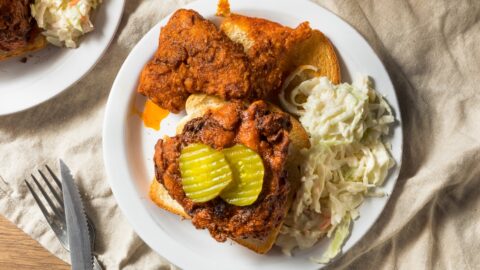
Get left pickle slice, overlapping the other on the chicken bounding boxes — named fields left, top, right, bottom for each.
left=180, top=143, right=233, bottom=202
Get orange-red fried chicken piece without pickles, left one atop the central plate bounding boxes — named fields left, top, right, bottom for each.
left=138, top=9, right=250, bottom=113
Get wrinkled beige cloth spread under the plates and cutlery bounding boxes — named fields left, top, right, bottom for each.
left=0, top=0, right=480, bottom=269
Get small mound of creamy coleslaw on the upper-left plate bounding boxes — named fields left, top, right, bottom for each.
left=31, top=0, right=102, bottom=48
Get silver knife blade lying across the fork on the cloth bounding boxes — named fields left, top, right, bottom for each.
left=60, top=160, right=93, bottom=270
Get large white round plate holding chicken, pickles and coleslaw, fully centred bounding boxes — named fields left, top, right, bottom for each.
left=103, top=0, right=402, bottom=270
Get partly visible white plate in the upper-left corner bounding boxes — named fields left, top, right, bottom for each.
left=0, top=0, right=125, bottom=115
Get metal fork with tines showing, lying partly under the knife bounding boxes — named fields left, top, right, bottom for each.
left=25, top=165, right=103, bottom=270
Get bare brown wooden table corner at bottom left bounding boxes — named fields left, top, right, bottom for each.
left=0, top=216, right=70, bottom=270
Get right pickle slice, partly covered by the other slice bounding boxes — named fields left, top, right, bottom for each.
left=220, top=144, right=265, bottom=206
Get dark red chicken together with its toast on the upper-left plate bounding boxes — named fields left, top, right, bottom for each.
left=0, top=0, right=47, bottom=61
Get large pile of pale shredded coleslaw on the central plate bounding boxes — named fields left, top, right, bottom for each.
left=277, top=76, right=394, bottom=263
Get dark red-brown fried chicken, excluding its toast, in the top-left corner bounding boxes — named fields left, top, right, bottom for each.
left=0, top=0, right=34, bottom=51
